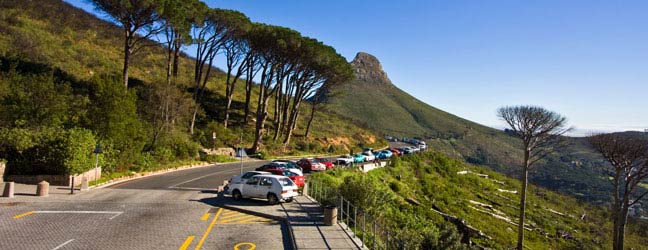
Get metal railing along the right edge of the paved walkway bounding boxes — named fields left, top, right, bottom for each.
left=309, top=182, right=407, bottom=250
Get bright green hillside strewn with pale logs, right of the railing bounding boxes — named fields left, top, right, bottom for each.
left=309, top=152, right=648, bottom=249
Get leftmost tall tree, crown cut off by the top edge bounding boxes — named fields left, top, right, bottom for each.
left=90, top=0, right=163, bottom=87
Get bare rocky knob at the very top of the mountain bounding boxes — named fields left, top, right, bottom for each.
left=351, top=52, right=391, bottom=84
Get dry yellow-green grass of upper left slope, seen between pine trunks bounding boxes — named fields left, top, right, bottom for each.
left=0, top=0, right=385, bottom=154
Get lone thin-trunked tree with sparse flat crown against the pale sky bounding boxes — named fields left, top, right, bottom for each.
left=497, top=106, right=569, bottom=250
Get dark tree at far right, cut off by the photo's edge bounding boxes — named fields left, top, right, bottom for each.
left=588, top=134, right=648, bottom=250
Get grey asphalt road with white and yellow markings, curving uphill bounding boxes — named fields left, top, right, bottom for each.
left=0, top=161, right=289, bottom=250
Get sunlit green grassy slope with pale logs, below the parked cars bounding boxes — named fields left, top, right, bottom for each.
left=311, top=152, right=648, bottom=249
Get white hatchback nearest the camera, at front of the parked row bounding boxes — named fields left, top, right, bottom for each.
left=230, top=174, right=298, bottom=205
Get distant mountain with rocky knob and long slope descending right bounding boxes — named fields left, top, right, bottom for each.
left=326, top=52, right=624, bottom=206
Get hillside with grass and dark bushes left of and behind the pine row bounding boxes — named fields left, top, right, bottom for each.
left=0, top=0, right=386, bottom=176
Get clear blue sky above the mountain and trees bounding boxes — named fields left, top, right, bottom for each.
left=68, top=0, right=648, bottom=133
